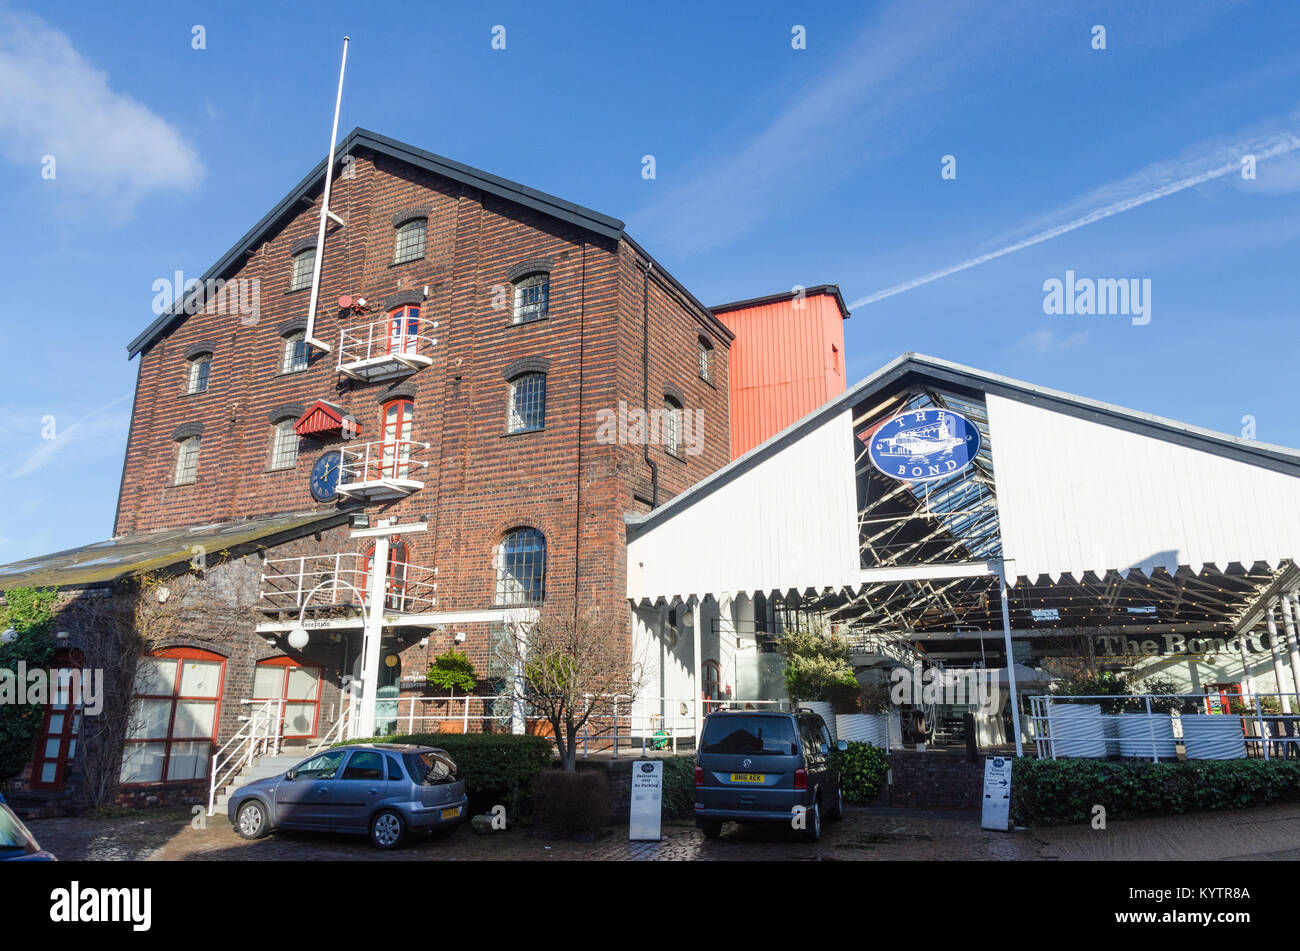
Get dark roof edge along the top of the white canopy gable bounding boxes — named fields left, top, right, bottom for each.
left=624, top=353, right=1300, bottom=542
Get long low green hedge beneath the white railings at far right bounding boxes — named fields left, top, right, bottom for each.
left=1011, top=759, right=1300, bottom=825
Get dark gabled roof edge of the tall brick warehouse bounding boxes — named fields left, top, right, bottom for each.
left=126, top=127, right=731, bottom=359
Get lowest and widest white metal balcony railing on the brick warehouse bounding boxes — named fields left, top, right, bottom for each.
left=257, top=552, right=438, bottom=615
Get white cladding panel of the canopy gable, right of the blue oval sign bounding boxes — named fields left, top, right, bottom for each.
left=988, top=394, right=1300, bottom=579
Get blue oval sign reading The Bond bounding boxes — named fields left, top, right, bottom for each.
left=867, top=407, right=980, bottom=482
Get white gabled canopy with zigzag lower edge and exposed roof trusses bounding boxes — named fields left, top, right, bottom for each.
left=628, top=355, right=1300, bottom=635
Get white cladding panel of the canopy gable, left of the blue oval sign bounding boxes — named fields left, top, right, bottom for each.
left=628, top=409, right=859, bottom=600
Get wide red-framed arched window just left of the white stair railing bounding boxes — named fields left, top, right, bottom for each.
left=121, top=647, right=226, bottom=783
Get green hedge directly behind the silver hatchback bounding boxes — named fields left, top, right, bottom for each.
left=334, top=733, right=555, bottom=813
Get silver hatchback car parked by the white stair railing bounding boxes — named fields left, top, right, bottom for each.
left=229, top=743, right=468, bottom=848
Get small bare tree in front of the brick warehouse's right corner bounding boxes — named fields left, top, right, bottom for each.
left=498, top=611, right=641, bottom=770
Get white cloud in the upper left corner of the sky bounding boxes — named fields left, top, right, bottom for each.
left=0, top=8, right=204, bottom=216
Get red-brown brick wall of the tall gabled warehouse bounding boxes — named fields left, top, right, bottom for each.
left=117, top=140, right=729, bottom=669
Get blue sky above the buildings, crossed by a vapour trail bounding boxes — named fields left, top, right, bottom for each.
left=0, top=0, right=1300, bottom=563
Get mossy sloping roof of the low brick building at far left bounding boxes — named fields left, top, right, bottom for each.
left=0, top=512, right=348, bottom=591
